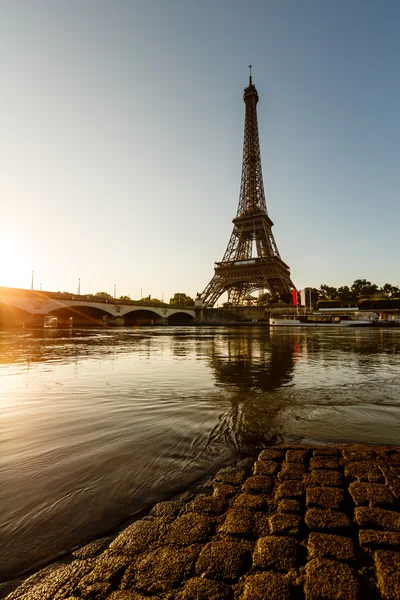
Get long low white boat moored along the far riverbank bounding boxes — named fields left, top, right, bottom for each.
left=269, top=313, right=374, bottom=327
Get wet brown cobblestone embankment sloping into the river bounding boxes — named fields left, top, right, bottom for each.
left=3, top=445, right=400, bottom=600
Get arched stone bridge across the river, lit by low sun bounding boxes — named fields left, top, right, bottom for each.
left=0, top=287, right=196, bottom=327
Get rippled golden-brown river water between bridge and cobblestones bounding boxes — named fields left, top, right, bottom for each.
left=0, top=326, right=400, bottom=581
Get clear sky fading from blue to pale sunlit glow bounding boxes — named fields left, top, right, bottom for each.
left=0, top=0, right=400, bottom=299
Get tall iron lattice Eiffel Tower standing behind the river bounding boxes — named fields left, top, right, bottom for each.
left=196, top=66, right=296, bottom=307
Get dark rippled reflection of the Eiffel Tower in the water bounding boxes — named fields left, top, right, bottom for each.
left=208, top=328, right=295, bottom=451
